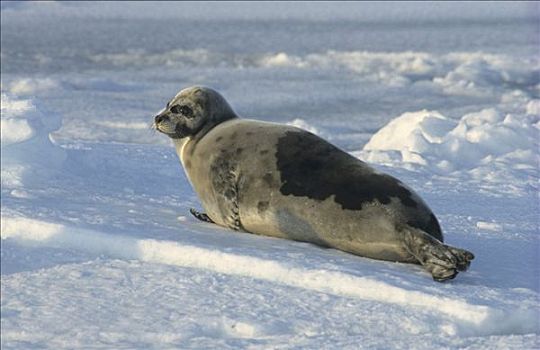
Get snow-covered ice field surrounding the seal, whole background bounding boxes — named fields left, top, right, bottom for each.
left=1, top=2, right=540, bottom=349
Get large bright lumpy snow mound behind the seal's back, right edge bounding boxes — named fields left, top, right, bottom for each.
left=357, top=105, right=540, bottom=194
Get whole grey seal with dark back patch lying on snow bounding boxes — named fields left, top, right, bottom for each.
left=154, top=87, right=474, bottom=281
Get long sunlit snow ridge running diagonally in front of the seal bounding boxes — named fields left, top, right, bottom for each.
left=2, top=217, right=524, bottom=335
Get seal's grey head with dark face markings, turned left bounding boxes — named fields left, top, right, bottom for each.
left=154, top=86, right=237, bottom=139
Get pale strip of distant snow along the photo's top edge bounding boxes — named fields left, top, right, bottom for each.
left=2, top=1, right=535, bottom=22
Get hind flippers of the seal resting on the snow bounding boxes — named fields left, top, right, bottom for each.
left=401, top=225, right=474, bottom=282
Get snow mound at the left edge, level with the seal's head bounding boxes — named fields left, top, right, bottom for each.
left=0, top=94, right=66, bottom=187
